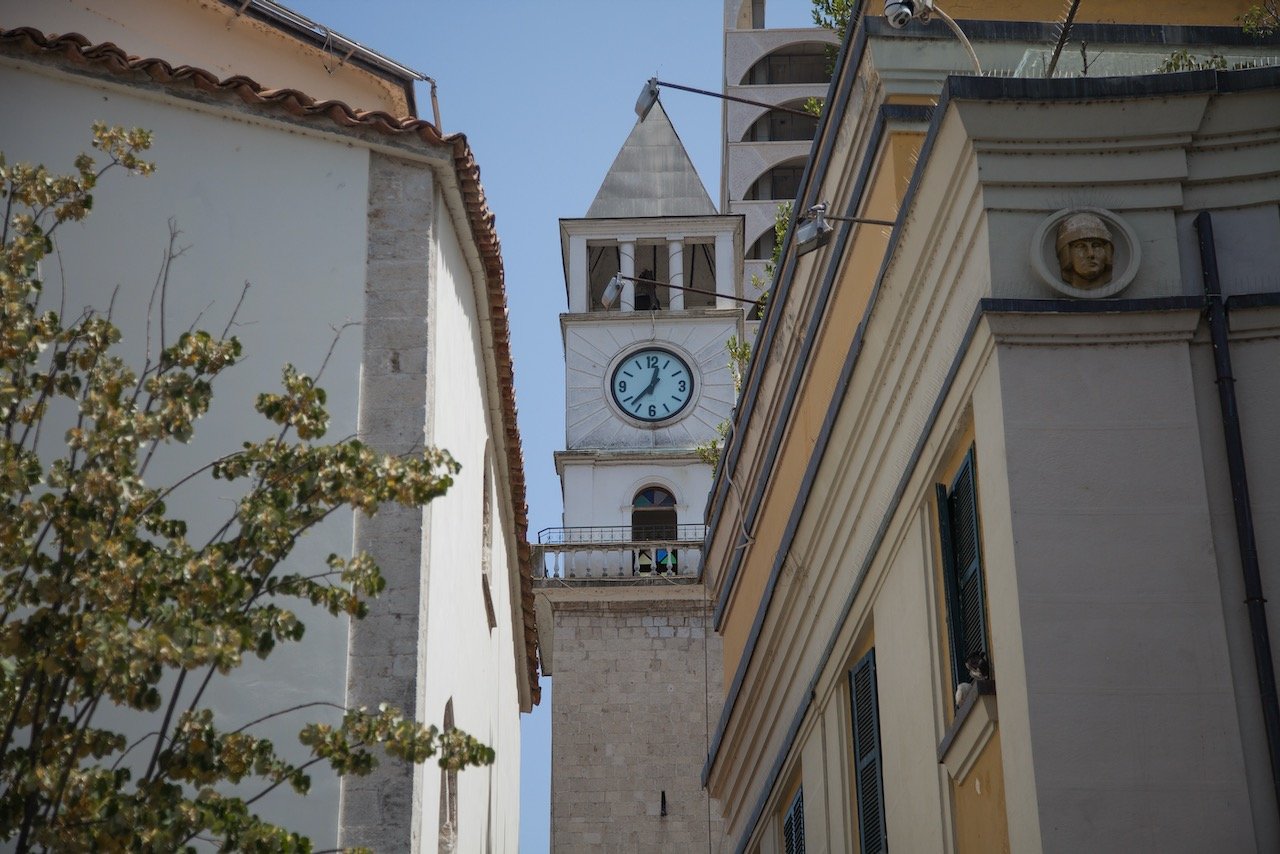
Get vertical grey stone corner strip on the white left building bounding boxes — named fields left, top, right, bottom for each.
left=338, top=152, right=433, bottom=851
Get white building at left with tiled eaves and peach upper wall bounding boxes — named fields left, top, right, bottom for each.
left=0, top=0, right=537, bottom=851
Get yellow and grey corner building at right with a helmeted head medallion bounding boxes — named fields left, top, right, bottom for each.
left=704, top=0, right=1280, bottom=854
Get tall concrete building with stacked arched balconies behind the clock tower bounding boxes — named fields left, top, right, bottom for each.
left=719, top=0, right=838, bottom=296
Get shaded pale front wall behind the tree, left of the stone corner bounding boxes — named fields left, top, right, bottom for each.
left=0, top=51, right=369, bottom=844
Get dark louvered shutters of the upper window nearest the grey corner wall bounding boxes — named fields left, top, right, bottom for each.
left=938, top=451, right=987, bottom=685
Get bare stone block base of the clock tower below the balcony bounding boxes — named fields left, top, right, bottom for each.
left=552, top=597, right=723, bottom=854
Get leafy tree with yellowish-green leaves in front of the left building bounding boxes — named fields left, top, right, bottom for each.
left=0, top=125, right=493, bottom=851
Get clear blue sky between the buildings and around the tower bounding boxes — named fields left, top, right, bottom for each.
left=283, top=0, right=810, bottom=854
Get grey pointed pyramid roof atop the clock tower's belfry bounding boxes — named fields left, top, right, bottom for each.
left=586, top=101, right=716, bottom=218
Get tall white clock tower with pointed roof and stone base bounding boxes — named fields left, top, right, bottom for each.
left=534, top=104, right=755, bottom=851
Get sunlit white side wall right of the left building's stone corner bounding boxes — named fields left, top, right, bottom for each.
left=416, top=185, right=520, bottom=851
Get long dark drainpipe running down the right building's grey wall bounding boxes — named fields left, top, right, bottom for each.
left=1196, top=211, right=1280, bottom=812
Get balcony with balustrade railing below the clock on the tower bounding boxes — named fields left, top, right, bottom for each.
left=532, top=525, right=707, bottom=583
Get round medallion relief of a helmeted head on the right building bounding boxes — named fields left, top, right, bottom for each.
left=1030, top=207, right=1142, bottom=300
